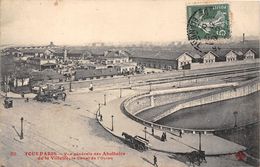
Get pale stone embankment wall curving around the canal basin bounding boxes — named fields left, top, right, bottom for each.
left=122, top=78, right=260, bottom=134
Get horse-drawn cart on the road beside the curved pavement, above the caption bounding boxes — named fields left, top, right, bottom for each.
left=122, top=132, right=149, bottom=151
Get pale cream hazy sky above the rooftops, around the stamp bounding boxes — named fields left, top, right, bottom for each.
left=0, top=0, right=260, bottom=45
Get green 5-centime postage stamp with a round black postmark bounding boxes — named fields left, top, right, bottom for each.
left=187, top=4, right=230, bottom=40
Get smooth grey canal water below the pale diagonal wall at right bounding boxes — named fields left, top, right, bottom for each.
left=156, top=91, right=260, bottom=129
